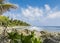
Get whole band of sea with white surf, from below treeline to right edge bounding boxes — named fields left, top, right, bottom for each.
left=14, top=26, right=60, bottom=32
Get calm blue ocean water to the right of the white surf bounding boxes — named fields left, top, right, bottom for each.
left=39, top=26, right=60, bottom=32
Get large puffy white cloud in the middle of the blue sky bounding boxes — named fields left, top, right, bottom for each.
left=22, top=6, right=43, bottom=19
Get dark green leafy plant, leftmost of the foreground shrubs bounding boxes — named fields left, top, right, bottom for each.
left=8, top=31, right=20, bottom=43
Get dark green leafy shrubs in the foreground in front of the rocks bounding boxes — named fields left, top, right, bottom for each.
left=8, top=31, right=42, bottom=43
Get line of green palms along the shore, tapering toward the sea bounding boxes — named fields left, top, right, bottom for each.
left=0, top=16, right=30, bottom=26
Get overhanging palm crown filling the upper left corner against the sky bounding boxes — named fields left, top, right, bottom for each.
left=0, top=0, right=17, bottom=15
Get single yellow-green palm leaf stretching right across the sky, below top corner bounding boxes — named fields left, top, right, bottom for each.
left=0, top=4, right=17, bottom=14
